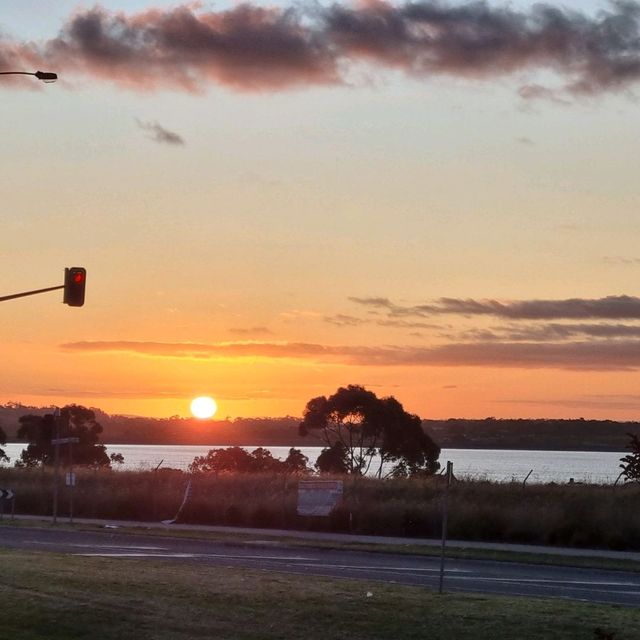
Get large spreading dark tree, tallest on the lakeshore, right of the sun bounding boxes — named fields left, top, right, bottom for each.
left=299, top=385, right=440, bottom=477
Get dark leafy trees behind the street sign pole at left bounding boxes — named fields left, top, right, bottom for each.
left=16, top=404, right=121, bottom=467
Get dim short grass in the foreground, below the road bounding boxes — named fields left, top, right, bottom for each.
left=0, top=550, right=640, bottom=640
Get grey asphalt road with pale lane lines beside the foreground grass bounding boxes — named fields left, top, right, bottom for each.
left=0, top=527, right=640, bottom=607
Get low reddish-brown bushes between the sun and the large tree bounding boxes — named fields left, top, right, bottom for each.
left=189, top=447, right=310, bottom=474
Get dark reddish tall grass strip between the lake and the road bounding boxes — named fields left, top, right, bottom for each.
left=0, top=468, right=640, bottom=549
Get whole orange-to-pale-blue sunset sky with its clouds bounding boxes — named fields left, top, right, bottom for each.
left=0, top=0, right=640, bottom=420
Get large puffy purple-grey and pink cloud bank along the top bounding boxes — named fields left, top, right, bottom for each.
left=0, top=0, right=640, bottom=95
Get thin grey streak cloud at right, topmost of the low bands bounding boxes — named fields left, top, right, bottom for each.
left=349, top=296, right=640, bottom=320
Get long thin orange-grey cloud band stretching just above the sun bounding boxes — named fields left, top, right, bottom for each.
left=61, top=340, right=640, bottom=371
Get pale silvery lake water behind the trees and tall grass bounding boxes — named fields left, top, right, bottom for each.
left=3, top=443, right=624, bottom=484
